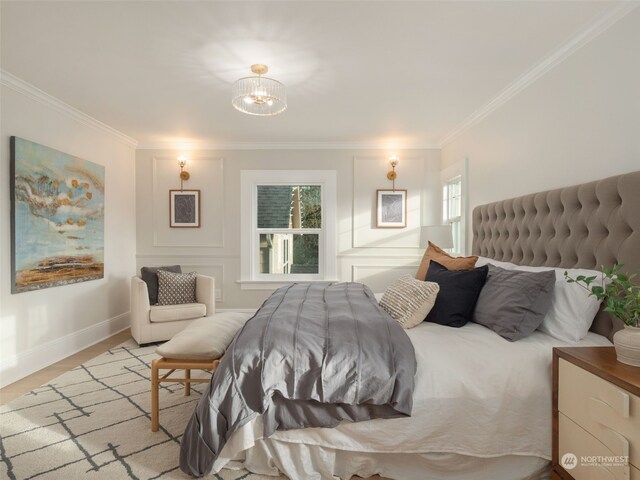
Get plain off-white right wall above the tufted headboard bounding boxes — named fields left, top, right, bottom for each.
left=442, top=8, right=640, bottom=255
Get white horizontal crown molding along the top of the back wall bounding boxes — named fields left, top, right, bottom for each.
left=137, top=142, right=440, bottom=150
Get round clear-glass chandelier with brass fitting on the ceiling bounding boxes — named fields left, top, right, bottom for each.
left=231, top=64, right=287, bottom=116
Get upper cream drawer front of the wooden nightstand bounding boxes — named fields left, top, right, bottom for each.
left=558, top=359, right=640, bottom=467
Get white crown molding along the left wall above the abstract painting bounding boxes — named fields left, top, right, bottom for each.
left=0, top=69, right=138, bottom=148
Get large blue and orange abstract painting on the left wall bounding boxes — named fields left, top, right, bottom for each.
left=10, top=137, right=104, bottom=293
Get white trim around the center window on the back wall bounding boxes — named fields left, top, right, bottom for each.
left=238, top=170, right=338, bottom=290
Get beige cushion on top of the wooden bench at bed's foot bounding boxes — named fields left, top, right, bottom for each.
left=156, top=312, right=252, bottom=360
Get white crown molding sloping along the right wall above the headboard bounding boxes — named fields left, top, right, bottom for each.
left=438, top=1, right=640, bottom=148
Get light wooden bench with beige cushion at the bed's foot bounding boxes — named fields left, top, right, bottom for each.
left=151, top=312, right=252, bottom=432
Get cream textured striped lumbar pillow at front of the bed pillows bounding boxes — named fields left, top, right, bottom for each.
left=380, top=275, right=440, bottom=328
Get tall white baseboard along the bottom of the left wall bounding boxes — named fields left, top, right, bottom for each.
left=0, top=312, right=130, bottom=388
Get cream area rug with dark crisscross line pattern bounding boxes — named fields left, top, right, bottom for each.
left=0, top=340, right=284, bottom=480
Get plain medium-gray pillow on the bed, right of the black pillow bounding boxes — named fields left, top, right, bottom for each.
left=473, top=264, right=556, bottom=342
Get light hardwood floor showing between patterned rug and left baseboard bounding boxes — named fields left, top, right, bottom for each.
left=0, top=328, right=387, bottom=480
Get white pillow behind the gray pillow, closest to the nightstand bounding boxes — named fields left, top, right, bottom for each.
left=515, top=266, right=602, bottom=343
